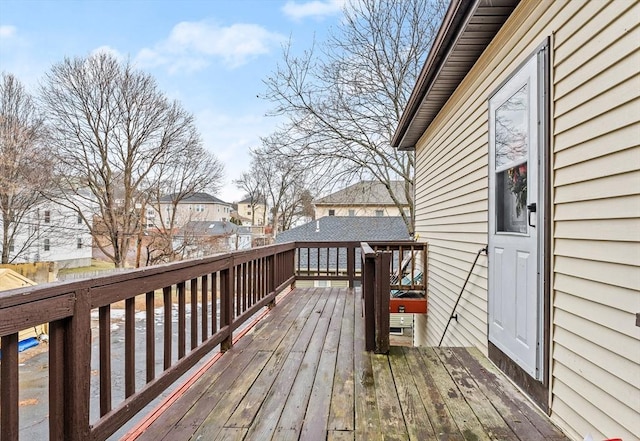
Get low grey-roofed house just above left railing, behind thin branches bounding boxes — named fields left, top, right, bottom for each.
left=173, top=221, right=252, bottom=258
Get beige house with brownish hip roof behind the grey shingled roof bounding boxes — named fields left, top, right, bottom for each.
left=313, top=181, right=409, bottom=219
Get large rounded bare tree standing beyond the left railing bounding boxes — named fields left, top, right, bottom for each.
left=41, top=53, right=222, bottom=267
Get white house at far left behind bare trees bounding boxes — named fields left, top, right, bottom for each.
left=0, top=201, right=93, bottom=268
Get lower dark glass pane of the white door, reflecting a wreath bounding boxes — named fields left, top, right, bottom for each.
left=496, top=162, right=527, bottom=233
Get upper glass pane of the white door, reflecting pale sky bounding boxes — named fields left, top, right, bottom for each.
left=495, top=84, right=529, bottom=170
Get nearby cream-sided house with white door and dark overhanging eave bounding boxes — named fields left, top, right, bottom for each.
left=392, top=0, right=640, bottom=440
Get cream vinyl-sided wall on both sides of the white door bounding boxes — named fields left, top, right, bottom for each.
left=416, top=0, right=640, bottom=440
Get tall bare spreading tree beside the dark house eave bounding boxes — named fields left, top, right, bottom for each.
left=265, top=0, right=445, bottom=232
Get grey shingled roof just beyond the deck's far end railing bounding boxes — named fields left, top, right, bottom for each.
left=276, top=216, right=411, bottom=243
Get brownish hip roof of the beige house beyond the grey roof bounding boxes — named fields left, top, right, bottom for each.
left=314, top=181, right=408, bottom=206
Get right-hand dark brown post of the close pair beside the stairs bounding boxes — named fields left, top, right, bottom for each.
left=374, top=251, right=391, bottom=354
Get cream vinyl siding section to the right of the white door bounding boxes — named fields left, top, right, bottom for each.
left=552, top=1, right=640, bottom=439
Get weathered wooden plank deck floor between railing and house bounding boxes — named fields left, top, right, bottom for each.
left=138, top=288, right=566, bottom=441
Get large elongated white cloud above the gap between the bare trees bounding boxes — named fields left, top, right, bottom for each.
left=134, top=21, right=285, bottom=73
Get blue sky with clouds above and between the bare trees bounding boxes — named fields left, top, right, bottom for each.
left=0, top=0, right=344, bottom=202
